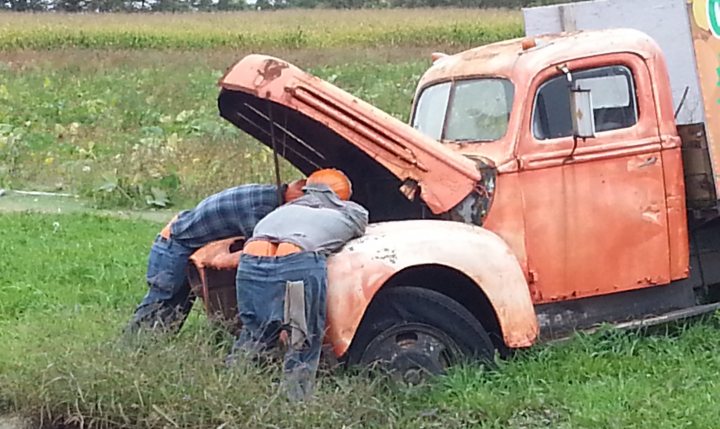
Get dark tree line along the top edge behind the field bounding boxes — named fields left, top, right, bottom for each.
left=0, top=0, right=567, bottom=12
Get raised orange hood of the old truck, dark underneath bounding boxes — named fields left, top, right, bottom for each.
left=218, top=55, right=481, bottom=214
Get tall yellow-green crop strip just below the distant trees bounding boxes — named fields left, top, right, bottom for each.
left=0, top=9, right=522, bottom=50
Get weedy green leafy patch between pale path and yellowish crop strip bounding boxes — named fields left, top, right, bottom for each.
left=0, top=51, right=427, bottom=207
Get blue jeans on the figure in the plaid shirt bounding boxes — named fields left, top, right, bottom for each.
left=127, top=235, right=195, bottom=332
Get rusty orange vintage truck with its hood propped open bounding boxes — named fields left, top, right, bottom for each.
left=189, top=0, right=720, bottom=375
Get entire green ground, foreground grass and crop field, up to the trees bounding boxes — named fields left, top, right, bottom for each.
left=0, top=9, right=720, bottom=429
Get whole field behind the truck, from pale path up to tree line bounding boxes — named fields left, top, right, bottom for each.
left=0, top=9, right=521, bottom=207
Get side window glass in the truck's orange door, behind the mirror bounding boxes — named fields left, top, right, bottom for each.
left=532, top=66, right=638, bottom=140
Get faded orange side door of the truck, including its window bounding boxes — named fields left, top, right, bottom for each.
left=518, top=54, right=670, bottom=303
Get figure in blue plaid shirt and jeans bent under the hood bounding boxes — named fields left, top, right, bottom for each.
left=127, top=180, right=305, bottom=332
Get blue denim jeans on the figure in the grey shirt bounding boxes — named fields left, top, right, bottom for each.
left=235, top=252, right=327, bottom=400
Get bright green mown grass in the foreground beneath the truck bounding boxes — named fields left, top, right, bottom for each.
left=0, top=214, right=720, bottom=429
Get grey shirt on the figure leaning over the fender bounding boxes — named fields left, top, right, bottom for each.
left=251, top=184, right=368, bottom=254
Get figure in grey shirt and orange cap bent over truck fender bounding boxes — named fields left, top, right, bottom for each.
left=234, top=169, right=368, bottom=400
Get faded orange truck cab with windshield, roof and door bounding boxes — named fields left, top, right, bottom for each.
left=412, top=30, right=688, bottom=304
